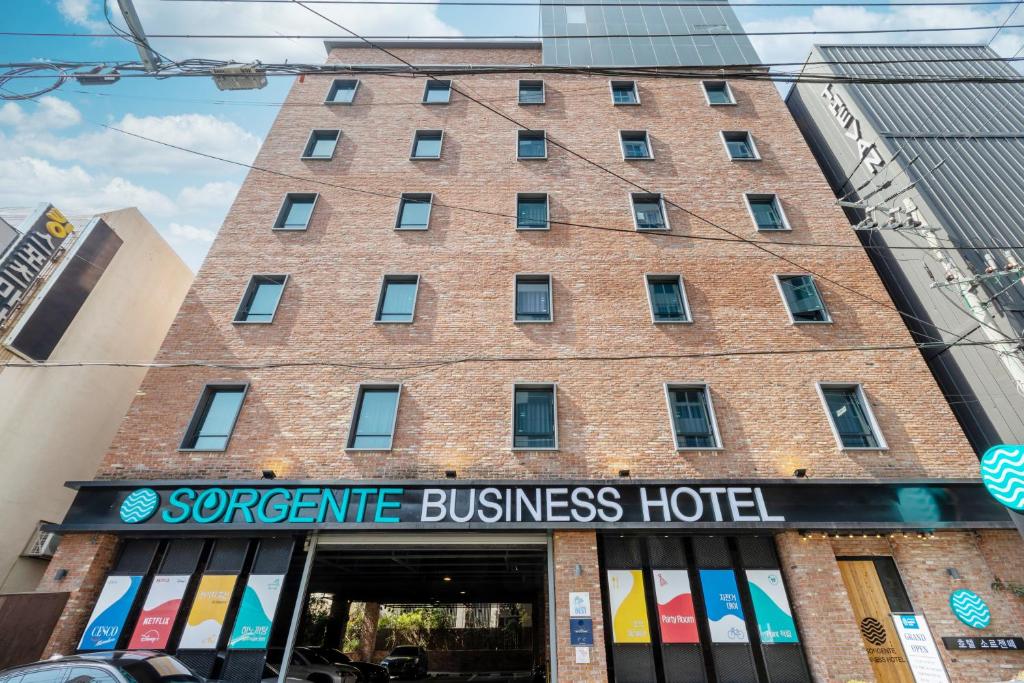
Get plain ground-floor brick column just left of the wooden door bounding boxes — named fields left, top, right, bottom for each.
left=775, top=531, right=874, bottom=683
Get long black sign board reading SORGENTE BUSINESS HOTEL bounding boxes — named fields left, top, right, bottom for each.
left=53, top=479, right=1012, bottom=532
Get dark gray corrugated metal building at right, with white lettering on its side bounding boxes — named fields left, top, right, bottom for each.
left=786, top=45, right=1024, bottom=454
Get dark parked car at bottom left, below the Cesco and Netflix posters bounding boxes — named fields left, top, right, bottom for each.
left=0, top=650, right=205, bottom=683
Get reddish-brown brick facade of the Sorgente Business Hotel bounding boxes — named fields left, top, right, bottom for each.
left=45, top=44, right=1024, bottom=682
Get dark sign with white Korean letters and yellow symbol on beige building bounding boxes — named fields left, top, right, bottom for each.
left=0, top=205, right=75, bottom=325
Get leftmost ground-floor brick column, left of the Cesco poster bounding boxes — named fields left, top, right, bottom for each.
left=37, top=533, right=118, bottom=657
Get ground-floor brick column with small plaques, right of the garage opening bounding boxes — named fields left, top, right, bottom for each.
left=554, top=531, right=608, bottom=683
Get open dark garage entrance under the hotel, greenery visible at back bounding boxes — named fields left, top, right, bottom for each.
left=293, top=532, right=550, bottom=683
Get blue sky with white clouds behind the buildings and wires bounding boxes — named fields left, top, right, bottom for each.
left=0, top=0, right=1024, bottom=269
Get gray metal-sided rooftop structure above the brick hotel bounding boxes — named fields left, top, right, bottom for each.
left=541, top=0, right=761, bottom=67
